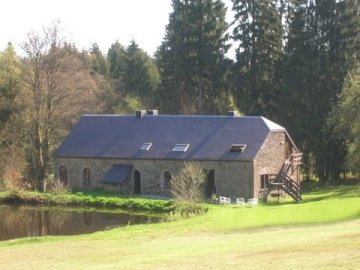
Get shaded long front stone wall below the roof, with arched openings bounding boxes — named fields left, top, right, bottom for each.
left=55, top=158, right=254, bottom=199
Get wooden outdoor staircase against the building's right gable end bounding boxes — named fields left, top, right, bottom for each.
left=269, top=153, right=302, bottom=202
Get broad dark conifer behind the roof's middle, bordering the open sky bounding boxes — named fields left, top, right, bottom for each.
left=156, top=0, right=229, bottom=114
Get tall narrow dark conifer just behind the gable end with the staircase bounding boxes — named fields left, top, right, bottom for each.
left=279, top=0, right=321, bottom=179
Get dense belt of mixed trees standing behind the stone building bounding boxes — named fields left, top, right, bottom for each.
left=0, top=0, right=360, bottom=189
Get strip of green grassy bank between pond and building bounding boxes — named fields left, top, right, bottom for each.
left=0, top=191, right=174, bottom=213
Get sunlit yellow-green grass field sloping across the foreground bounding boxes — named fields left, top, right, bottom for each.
left=0, top=182, right=360, bottom=269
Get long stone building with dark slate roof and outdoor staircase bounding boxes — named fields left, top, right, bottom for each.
left=54, top=110, right=301, bottom=200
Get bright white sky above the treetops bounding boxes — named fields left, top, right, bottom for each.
left=0, top=0, right=232, bottom=55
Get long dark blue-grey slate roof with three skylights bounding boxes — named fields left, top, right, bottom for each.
left=54, top=115, right=286, bottom=160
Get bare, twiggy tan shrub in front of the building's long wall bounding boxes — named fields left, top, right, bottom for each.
left=169, top=162, right=206, bottom=204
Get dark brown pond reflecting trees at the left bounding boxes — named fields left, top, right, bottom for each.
left=0, top=205, right=160, bottom=241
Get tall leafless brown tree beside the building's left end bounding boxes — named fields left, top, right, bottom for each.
left=18, top=25, right=96, bottom=189
